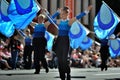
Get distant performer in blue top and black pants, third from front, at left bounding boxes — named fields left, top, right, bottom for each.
left=23, top=29, right=33, bottom=69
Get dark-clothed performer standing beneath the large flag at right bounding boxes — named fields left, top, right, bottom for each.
left=100, top=39, right=110, bottom=71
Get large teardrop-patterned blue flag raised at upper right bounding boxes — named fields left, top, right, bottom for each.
left=93, top=2, right=120, bottom=39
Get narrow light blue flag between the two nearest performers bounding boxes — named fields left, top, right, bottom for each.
left=45, top=31, right=54, bottom=51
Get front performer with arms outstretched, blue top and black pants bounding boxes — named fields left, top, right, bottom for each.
left=45, top=6, right=92, bottom=80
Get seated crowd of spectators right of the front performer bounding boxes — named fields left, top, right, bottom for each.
left=70, top=44, right=120, bottom=68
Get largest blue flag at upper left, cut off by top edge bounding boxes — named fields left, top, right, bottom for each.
left=8, top=0, right=38, bottom=29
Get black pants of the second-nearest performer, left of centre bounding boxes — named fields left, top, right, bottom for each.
left=33, top=37, right=48, bottom=73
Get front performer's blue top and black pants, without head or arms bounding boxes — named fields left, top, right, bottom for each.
left=54, top=20, right=71, bottom=80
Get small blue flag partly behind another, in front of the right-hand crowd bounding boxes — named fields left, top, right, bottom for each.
left=80, top=36, right=93, bottom=50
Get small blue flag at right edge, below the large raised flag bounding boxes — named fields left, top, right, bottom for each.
left=109, top=38, right=120, bottom=58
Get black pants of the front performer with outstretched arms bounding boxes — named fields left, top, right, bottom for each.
left=55, top=36, right=70, bottom=80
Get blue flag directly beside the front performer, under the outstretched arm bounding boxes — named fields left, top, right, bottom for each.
left=69, top=21, right=86, bottom=49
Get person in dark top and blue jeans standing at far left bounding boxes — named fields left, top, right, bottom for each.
left=9, top=34, right=21, bottom=69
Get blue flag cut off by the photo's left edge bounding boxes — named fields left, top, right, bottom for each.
left=0, top=0, right=15, bottom=37
